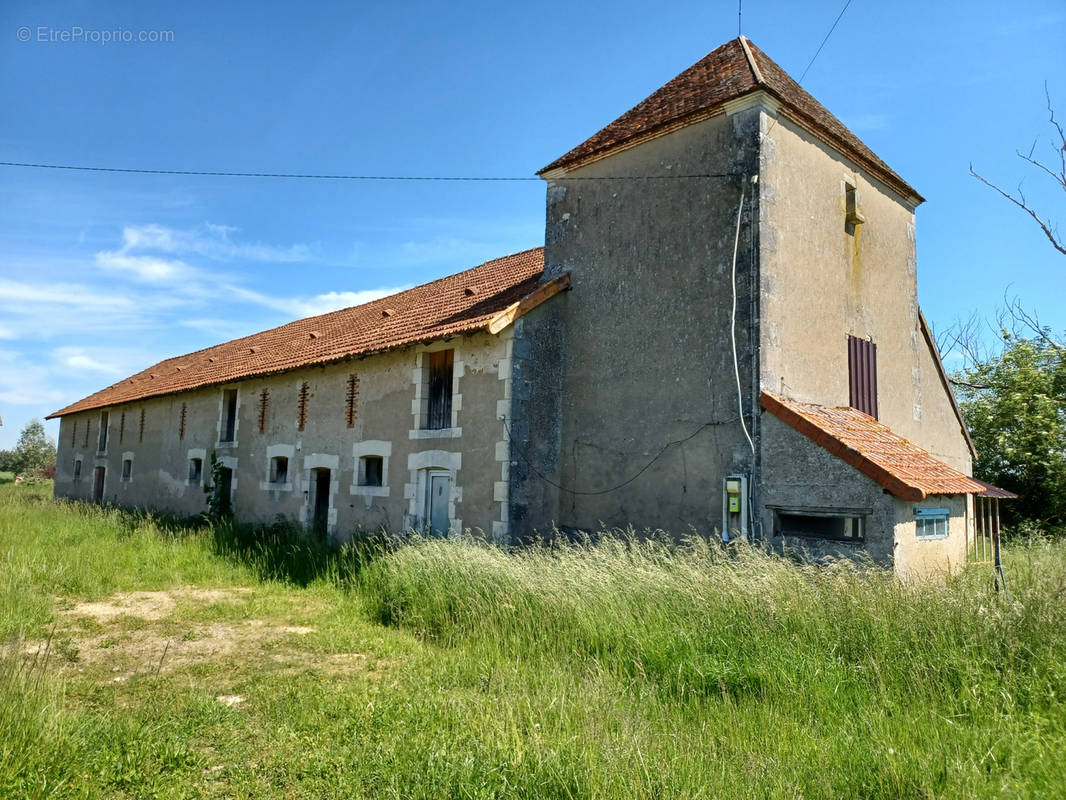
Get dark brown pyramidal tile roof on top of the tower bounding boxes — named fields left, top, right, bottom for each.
left=539, top=38, right=922, bottom=202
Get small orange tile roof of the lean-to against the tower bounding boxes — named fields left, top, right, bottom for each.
left=761, top=391, right=984, bottom=500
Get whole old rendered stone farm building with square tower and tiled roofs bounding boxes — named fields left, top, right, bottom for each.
left=52, top=37, right=984, bottom=573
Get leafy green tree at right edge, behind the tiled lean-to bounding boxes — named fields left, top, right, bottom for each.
left=955, top=329, right=1066, bottom=525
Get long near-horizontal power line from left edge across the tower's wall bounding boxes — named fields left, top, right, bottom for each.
left=0, top=161, right=737, bottom=182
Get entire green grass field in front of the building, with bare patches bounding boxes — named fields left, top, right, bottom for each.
left=0, top=484, right=1066, bottom=798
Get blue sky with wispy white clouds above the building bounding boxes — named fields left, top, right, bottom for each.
left=0, top=0, right=1066, bottom=447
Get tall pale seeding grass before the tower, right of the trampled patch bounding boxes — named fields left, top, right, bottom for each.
left=361, top=538, right=1066, bottom=796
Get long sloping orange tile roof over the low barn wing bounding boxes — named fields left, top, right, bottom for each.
left=49, top=247, right=544, bottom=419
